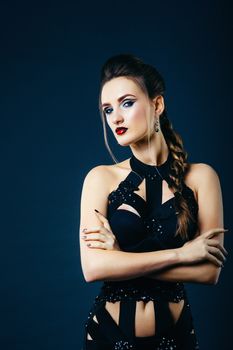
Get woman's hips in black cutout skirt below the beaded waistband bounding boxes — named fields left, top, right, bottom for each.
left=84, top=298, right=199, bottom=350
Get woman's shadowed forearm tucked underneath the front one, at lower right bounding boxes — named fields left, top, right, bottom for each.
left=147, top=262, right=221, bottom=284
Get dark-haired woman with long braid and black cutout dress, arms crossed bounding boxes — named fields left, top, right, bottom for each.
left=80, top=54, right=227, bottom=350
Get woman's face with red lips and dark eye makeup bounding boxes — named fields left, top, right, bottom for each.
left=101, top=77, right=155, bottom=146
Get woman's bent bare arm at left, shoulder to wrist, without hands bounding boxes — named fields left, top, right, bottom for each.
left=80, top=165, right=181, bottom=282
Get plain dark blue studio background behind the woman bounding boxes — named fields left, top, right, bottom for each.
left=0, top=1, right=233, bottom=350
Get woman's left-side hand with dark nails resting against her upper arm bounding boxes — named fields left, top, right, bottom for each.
left=82, top=212, right=121, bottom=250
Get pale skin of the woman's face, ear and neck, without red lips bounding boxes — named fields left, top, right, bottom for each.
left=101, top=77, right=169, bottom=165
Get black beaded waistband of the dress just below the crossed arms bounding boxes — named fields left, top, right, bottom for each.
left=96, top=277, right=186, bottom=303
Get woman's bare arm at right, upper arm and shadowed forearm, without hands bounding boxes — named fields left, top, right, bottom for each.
left=148, top=163, right=226, bottom=284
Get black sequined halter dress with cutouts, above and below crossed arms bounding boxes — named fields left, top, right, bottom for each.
left=83, top=153, right=199, bottom=350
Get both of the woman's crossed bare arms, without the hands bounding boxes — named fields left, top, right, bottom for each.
left=80, top=164, right=228, bottom=284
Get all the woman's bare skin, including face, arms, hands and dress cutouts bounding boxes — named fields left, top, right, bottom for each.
left=80, top=77, right=227, bottom=339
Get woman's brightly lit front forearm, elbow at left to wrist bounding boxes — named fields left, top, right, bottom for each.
left=82, top=249, right=181, bottom=282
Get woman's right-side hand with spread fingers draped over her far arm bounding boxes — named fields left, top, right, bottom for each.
left=178, top=228, right=228, bottom=267
